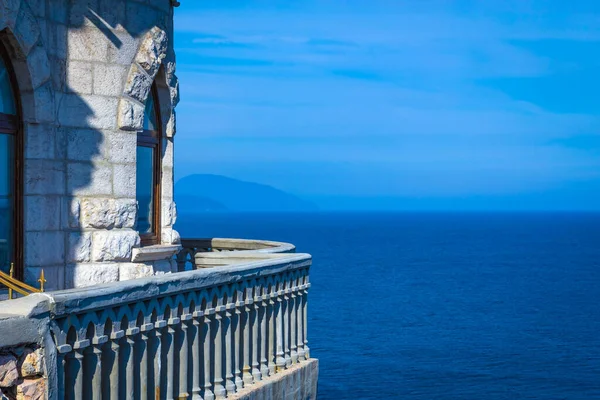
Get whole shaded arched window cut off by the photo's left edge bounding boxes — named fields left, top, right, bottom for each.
left=0, top=43, right=23, bottom=279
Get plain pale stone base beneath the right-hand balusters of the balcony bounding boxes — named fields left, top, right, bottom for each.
left=227, top=358, right=319, bottom=400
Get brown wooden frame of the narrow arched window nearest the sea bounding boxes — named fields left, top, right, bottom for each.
left=137, top=83, right=163, bottom=246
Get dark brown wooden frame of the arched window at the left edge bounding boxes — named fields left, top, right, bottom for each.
left=0, top=41, right=25, bottom=281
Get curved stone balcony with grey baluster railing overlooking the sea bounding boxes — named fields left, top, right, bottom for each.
left=0, top=239, right=318, bottom=399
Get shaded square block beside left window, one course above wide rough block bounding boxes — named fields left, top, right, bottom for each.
left=24, top=196, right=60, bottom=231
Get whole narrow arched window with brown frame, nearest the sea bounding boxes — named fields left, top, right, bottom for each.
left=136, top=84, right=162, bottom=245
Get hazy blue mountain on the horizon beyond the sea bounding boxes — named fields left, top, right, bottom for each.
left=175, top=174, right=317, bottom=213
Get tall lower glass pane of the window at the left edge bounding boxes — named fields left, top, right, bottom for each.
left=0, top=134, right=15, bottom=272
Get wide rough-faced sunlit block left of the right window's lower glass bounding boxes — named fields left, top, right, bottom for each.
left=81, top=198, right=137, bottom=229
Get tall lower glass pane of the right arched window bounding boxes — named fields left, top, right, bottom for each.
left=136, top=146, right=154, bottom=233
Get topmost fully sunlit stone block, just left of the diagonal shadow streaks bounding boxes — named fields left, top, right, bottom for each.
left=67, top=27, right=109, bottom=61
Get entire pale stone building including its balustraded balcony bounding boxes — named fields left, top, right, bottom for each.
left=0, top=0, right=318, bottom=400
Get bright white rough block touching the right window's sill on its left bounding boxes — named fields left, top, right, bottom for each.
left=92, top=230, right=140, bottom=261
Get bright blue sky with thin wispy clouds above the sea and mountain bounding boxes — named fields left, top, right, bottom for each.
left=175, top=0, right=600, bottom=209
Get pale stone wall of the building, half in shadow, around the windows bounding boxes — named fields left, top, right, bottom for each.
left=0, top=0, right=179, bottom=290
